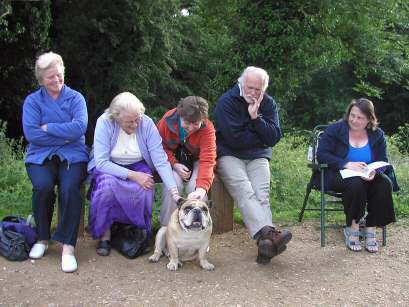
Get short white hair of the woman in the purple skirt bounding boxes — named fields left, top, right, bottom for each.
left=105, top=92, right=145, bottom=120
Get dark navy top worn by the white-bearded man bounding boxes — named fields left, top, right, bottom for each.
left=215, top=85, right=282, bottom=160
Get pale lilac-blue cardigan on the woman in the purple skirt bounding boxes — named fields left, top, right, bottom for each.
left=88, top=113, right=176, bottom=189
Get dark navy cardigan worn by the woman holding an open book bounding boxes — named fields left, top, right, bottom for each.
left=317, top=120, right=399, bottom=191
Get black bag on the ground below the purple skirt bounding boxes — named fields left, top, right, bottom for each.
left=111, top=223, right=150, bottom=259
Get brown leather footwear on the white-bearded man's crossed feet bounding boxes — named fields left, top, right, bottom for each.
left=257, top=226, right=292, bottom=263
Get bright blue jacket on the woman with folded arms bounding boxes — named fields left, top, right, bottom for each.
left=23, top=85, right=88, bottom=165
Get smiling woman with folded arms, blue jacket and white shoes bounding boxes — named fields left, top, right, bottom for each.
left=23, top=52, right=88, bottom=272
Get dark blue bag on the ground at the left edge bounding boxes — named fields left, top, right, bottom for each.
left=0, top=225, right=30, bottom=261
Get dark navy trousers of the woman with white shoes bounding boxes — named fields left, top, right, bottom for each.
left=26, top=156, right=87, bottom=246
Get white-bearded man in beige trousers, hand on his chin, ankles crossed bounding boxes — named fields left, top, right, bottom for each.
left=215, top=66, right=292, bottom=264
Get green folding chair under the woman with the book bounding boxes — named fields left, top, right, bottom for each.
left=298, top=125, right=386, bottom=247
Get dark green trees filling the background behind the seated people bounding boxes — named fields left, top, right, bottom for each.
left=0, top=0, right=409, bottom=141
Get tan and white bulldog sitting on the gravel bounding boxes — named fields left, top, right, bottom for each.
left=149, top=199, right=214, bottom=271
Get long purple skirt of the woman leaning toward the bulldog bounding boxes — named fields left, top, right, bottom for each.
left=89, top=161, right=155, bottom=239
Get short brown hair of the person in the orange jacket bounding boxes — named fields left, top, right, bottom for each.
left=177, top=96, right=209, bottom=123
